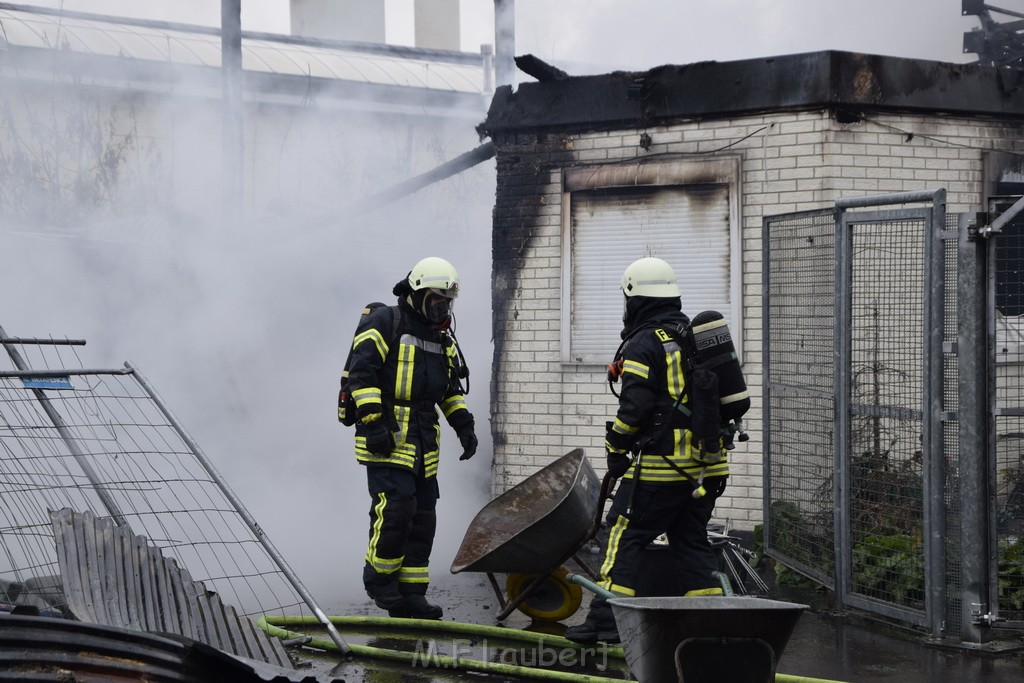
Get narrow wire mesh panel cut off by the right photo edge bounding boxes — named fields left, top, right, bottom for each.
left=994, top=210, right=1024, bottom=620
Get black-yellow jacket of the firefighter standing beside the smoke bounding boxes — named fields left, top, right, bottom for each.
left=348, top=300, right=473, bottom=477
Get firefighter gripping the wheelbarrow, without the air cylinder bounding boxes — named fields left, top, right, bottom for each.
left=565, top=257, right=729, bottom=643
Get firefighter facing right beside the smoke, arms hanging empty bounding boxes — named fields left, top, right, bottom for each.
left=348, top=257, right=477, bottom=620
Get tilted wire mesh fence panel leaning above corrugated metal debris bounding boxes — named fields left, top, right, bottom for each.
left=0, top=333, right=305, bottom=614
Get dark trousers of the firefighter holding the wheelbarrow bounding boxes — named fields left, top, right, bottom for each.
left=601, top=477, right=727, bottom=595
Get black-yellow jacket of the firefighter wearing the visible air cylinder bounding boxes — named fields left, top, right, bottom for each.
left=605, top=311, right=729, bottom=484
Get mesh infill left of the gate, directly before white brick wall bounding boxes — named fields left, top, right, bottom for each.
left=764, top=210, right=836, bottom=585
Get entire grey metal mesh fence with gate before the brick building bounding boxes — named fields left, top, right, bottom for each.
left=763, top=190, right=1024, bottom=642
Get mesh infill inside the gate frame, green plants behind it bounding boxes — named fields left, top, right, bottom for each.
left=847, top=219, right=926, bottom=609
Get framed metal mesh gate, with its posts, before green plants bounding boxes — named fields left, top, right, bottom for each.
left=837, top=209, right=942, bottom=625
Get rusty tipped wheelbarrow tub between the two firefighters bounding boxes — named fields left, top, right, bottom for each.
left=452, top=449, right=601, bottom=574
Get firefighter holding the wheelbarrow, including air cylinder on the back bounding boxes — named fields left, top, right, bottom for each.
left=565, top=257, right=750, bottom=643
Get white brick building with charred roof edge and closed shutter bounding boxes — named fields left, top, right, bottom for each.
left=480, top=52, right=1024, bottom=528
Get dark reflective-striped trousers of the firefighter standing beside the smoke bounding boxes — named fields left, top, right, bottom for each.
left=362, top=465, right=438, bottom=595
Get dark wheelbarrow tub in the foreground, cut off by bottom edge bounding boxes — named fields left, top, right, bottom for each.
left=608, top=596, right=809, bottom=682
